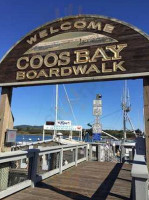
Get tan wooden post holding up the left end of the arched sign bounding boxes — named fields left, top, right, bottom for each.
left=0, top=87, right=13, bottom=152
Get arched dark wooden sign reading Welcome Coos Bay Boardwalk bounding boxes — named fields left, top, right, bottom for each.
left=0, top=15, right=149, bottom=86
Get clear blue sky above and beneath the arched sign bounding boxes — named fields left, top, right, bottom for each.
left=0, top=0, right=149, bottom=129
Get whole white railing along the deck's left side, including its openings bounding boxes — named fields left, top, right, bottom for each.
left=0, top=144, right=88, bottom=199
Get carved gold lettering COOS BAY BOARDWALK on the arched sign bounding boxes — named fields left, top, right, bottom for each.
left=16, top=44, right=127, bottom=80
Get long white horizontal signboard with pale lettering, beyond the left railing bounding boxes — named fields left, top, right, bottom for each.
left=44, top=125, right=82, bottom=131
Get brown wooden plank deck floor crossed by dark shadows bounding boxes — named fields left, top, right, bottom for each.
left=5, top=162, right=131, bottom=200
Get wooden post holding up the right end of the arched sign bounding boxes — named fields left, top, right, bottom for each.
left=143, top=77, right=149, bottom=170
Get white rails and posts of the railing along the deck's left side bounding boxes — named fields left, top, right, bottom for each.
left=0, top=143, right=88, bottom=199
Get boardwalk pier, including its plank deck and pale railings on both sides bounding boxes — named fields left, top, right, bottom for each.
left=0, top=141, right=148, bottom=200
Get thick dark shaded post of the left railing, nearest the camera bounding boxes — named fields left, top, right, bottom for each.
left=28, top=149, right=39, bottom=188
